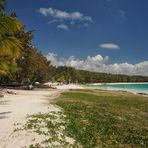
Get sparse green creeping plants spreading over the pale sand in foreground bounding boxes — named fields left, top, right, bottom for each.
left=14, top=111, right=80, bottom=148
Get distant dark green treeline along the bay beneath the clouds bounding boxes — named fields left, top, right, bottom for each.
left=51, top=66, right=148, bottom=83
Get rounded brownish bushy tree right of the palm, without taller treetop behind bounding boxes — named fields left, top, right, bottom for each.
left=16, top=47, right=51, bottom=84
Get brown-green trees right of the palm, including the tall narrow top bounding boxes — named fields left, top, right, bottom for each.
left=15, top=30, right=52, bottom=84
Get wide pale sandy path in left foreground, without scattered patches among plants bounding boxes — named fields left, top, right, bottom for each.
left=0, top=90, right=59, bottom=148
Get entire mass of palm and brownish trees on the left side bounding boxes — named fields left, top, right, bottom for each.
left=0, top=0, right=50, bottom=84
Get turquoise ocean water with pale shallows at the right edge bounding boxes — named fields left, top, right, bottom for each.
left=92, top=83, right=148, bottom=94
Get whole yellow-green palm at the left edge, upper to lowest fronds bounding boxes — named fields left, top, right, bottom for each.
left=0, top=0, right=23, bottom=75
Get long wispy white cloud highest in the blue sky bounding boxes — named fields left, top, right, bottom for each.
left=39, top=7, right=92, bottom=22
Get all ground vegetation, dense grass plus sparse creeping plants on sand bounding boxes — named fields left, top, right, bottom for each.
left=15, top=90, right=148, bottom=148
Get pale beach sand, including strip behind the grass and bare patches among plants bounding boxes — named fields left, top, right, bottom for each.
left=0, top=84, right=147, bottom=148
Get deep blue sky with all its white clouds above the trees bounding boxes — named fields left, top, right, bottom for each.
left=7, top=0, right=148, bottom=76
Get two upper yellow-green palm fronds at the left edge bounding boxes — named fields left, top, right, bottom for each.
left=0, top=14, right=23, bottom=57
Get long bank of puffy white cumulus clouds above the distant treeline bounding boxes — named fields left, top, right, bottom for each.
left=46, top=53, right=148, bottom=76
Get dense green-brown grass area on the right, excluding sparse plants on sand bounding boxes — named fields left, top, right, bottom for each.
left=56, top=90, right=148, bottom=148
